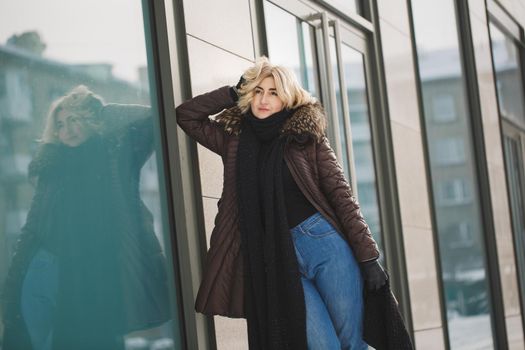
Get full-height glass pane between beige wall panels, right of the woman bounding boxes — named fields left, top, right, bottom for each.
left=411, top=0, right=493, bottom=349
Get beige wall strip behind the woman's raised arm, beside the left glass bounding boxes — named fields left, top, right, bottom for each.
left=180, top=0, right=254, bottom=350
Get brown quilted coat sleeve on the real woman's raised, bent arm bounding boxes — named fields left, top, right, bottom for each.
left=176, top=86, right=235, bottom=156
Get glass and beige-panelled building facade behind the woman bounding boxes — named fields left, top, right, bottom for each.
left=0, top=0, right=525, bottom=350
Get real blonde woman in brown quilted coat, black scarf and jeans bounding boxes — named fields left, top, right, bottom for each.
left=177, top=58, right=387, bottom=349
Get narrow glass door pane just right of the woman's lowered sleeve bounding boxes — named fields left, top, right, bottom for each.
left=341, top=44, right=385, bottom=259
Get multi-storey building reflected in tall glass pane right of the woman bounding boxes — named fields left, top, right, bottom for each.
left=419, top=45, right=489, bottom=315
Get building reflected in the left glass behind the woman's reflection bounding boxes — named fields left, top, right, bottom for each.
left=0, top=35, right=154, bottom=260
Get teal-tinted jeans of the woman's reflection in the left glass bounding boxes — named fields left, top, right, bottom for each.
left=21, top=249, right=58, bottom=350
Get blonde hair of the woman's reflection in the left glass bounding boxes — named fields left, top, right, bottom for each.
left=40, top=85, right=104, bottom=143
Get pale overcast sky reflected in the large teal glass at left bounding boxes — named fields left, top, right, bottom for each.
left=0, top=0, right=146, bottom=81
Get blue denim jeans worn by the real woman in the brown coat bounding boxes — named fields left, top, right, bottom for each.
left=291, top=213, right=368, bottom=350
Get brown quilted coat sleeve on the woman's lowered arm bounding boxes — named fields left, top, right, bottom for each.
left=316, top=138, right=379, bottom=262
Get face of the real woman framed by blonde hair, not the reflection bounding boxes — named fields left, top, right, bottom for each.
left=250, top=77, right=284, bottom=119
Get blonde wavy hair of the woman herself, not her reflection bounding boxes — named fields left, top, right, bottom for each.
left=237, top=56, right=316, bottom=113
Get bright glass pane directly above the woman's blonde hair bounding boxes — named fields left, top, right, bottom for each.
left=264, top=1, right=320, bottom=98
